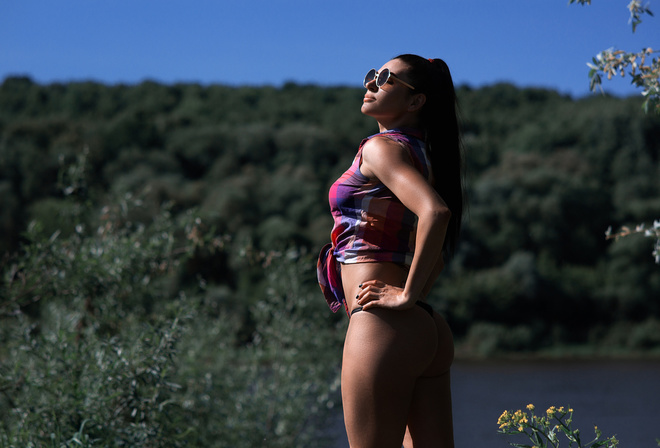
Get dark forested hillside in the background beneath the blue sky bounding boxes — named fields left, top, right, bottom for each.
left=0, top=77, right=660, bottom=353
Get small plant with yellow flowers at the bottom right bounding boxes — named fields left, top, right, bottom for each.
left=497, top=404, right=619, bottom=448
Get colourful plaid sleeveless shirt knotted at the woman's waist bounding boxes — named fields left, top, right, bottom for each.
left=317, top=129, right=431, bottom=312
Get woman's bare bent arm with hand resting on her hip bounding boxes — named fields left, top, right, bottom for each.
left=358, top=138, right=451, bottom=309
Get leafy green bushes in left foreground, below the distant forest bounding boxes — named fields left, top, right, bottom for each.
left=0, top=158, right=342, bottom=447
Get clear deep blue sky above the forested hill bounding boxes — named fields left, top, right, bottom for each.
left=0, top=0, right=660, bottom=96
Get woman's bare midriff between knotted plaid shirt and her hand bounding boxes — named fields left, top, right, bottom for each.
left=341, top=262, right=409, bottom=313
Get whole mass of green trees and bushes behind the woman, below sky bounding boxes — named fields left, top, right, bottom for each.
left=0, top=61, right=660, bottom=448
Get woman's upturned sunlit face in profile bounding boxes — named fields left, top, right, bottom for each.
left=361, top=59, right=413, bottom=123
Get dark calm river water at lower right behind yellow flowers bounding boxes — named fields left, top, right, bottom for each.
left=333, top=360, right=660, bottom=448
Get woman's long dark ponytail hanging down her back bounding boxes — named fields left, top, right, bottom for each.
left=394, top=54, right=465, bottom=255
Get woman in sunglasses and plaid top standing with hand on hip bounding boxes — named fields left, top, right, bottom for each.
left=318, top=55, right=463, bottom=448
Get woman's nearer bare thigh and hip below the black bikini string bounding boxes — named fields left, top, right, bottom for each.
left=341, top=307, right=436, bottom=448
